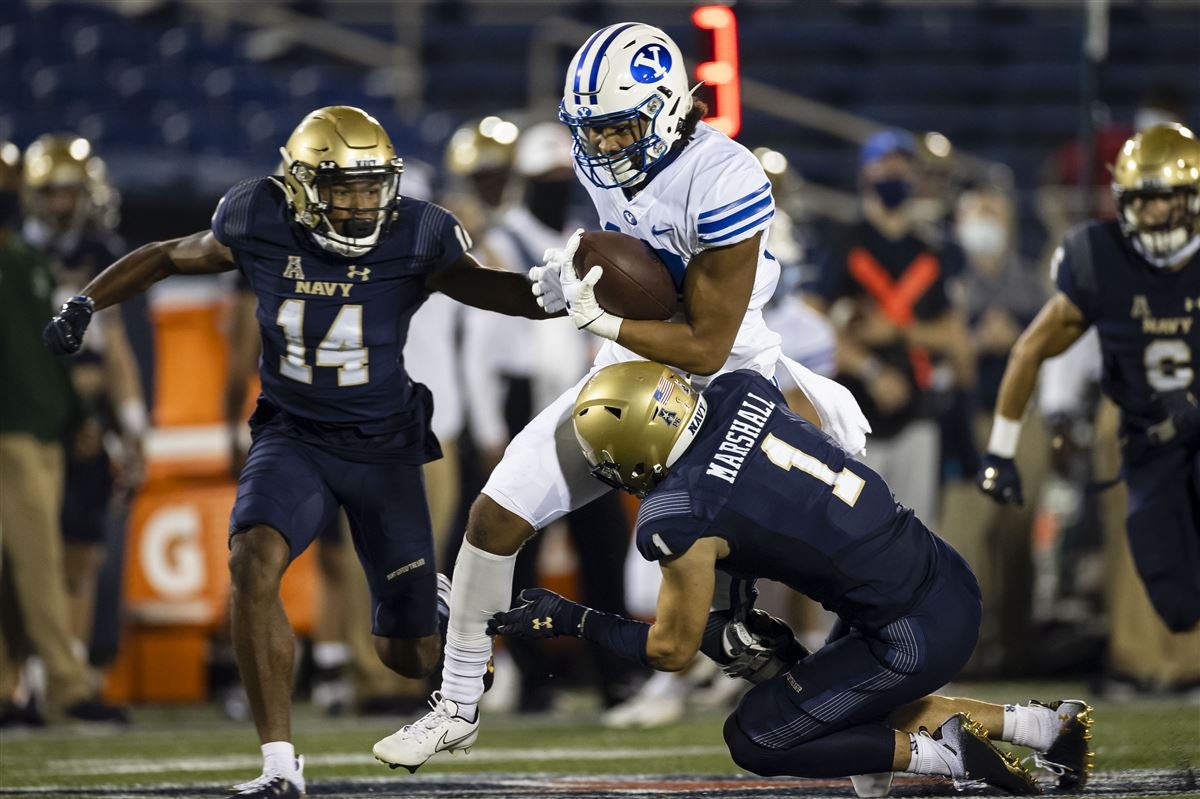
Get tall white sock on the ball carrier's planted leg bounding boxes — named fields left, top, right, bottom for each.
left=442, top=541, right=517, bottom=719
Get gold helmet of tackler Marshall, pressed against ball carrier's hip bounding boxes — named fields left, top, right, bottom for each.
left=574, top=361, right=708, bottom=497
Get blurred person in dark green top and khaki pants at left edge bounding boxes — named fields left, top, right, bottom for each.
left=0, top=142, right=125, bottom=723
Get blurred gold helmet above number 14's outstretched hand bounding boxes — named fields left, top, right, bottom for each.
left=23, top=133, right=116, bottom=230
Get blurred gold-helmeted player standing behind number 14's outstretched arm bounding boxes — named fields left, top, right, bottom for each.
left=24, top=134, right=149, bottom=662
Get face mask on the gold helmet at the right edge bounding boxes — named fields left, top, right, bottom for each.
left=1117, top=187, right=1200, bottom=269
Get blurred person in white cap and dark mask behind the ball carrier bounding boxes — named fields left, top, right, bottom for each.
left=463, top=122, right=631, bottom=711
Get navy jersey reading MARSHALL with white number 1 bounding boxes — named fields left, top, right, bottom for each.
left=635, top=371, right=938, bottom=629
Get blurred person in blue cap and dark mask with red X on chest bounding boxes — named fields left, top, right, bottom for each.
left=808, top=130, right=974, bottom=516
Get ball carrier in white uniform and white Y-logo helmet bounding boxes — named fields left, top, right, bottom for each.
left=373, top=23, right=869, bottom=771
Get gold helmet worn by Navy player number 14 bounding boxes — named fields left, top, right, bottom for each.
left=280, top=106, right=404, bottom=256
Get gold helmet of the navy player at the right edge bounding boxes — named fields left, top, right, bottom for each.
left=1112, top=122, right=1200, bottom=268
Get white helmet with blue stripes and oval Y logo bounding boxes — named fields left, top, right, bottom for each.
left=558, top=23, right=691, bottom=188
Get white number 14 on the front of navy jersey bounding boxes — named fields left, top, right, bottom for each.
left=275, top=300, right=368, bottom=385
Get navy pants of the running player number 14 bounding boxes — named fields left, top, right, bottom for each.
left=229, top=428, right=438, bottom=638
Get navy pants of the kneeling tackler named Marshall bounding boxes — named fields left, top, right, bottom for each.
left=725, top=542, right=982, bottom=777
